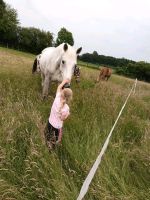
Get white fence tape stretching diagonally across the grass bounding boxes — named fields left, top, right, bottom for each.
left=77, top=79, right=137, bottom=200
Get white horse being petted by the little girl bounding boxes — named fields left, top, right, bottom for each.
left=32, top=43, right=82, bottom=98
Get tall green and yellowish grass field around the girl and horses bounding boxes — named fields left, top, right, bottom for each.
left=0, top=48, right=150, bottom=200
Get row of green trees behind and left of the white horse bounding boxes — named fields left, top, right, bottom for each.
left=0, top=0, right=74, bottom=54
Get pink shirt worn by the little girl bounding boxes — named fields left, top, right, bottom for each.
left=49, top=92, right=70, bottom=129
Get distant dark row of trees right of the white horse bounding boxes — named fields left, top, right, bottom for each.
left=79, top=51, right=150, bottom=82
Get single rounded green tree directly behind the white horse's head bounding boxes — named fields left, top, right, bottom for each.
left=55, top=28, right=74, bottom=46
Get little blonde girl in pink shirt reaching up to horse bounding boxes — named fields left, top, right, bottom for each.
left=45, top=80, right=72, bottom=149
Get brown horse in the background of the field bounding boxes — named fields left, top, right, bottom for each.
left=97, top=67, right=112, bottom=82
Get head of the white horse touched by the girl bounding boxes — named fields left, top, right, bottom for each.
left=60, top=43, right=82, bottom=80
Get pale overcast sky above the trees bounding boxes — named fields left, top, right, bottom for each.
left=4, top=0, right=150, bottom=62
